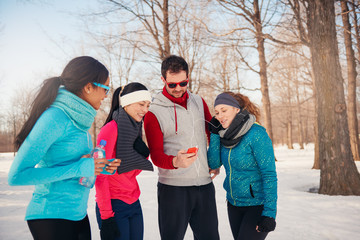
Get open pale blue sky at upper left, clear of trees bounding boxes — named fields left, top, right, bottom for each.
left=0, top=0, right=96, bottom=109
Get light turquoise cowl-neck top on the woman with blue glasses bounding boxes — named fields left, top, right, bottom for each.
left=8, top=88, right=96, bottom=221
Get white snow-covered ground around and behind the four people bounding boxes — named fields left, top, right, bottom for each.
left=0, top=145, right=360, bottom=240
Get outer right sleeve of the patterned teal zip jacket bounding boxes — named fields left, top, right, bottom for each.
left=251, top=128, right=277, bottom=218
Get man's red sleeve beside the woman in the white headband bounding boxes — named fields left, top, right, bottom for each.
left=144, top=112, right=175, bottom=169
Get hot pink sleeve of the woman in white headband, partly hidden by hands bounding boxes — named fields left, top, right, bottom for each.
left=95, top=121, right=117, bottom=220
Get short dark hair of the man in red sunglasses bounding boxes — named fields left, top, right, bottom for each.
left=161, top=55, right=189, bottom=79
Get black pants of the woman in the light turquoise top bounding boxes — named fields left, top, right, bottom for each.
left=27, top=215, right=91, bottom=240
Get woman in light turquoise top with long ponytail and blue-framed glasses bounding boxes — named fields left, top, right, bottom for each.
left=8, top=56, right=120, bottom=240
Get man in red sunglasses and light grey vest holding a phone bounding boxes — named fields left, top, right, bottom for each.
left=144, top=55, right=219, bottom=240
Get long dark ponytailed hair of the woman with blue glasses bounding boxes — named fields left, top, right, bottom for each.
left=14, top=56, right=109, bottom=149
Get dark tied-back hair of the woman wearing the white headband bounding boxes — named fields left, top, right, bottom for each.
left=104, top=82, right=148, bottom=126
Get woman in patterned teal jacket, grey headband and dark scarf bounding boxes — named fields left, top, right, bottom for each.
left=208, top=92, right=277, bottom=240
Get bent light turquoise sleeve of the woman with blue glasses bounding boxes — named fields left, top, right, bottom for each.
left=8, top=112, right=94, bottom=185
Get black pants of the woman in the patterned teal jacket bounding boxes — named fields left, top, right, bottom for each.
left=227, top=202, right=268, bottom=240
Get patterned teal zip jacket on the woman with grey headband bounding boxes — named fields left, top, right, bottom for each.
left=208, top=124, right=277, bottom=218
